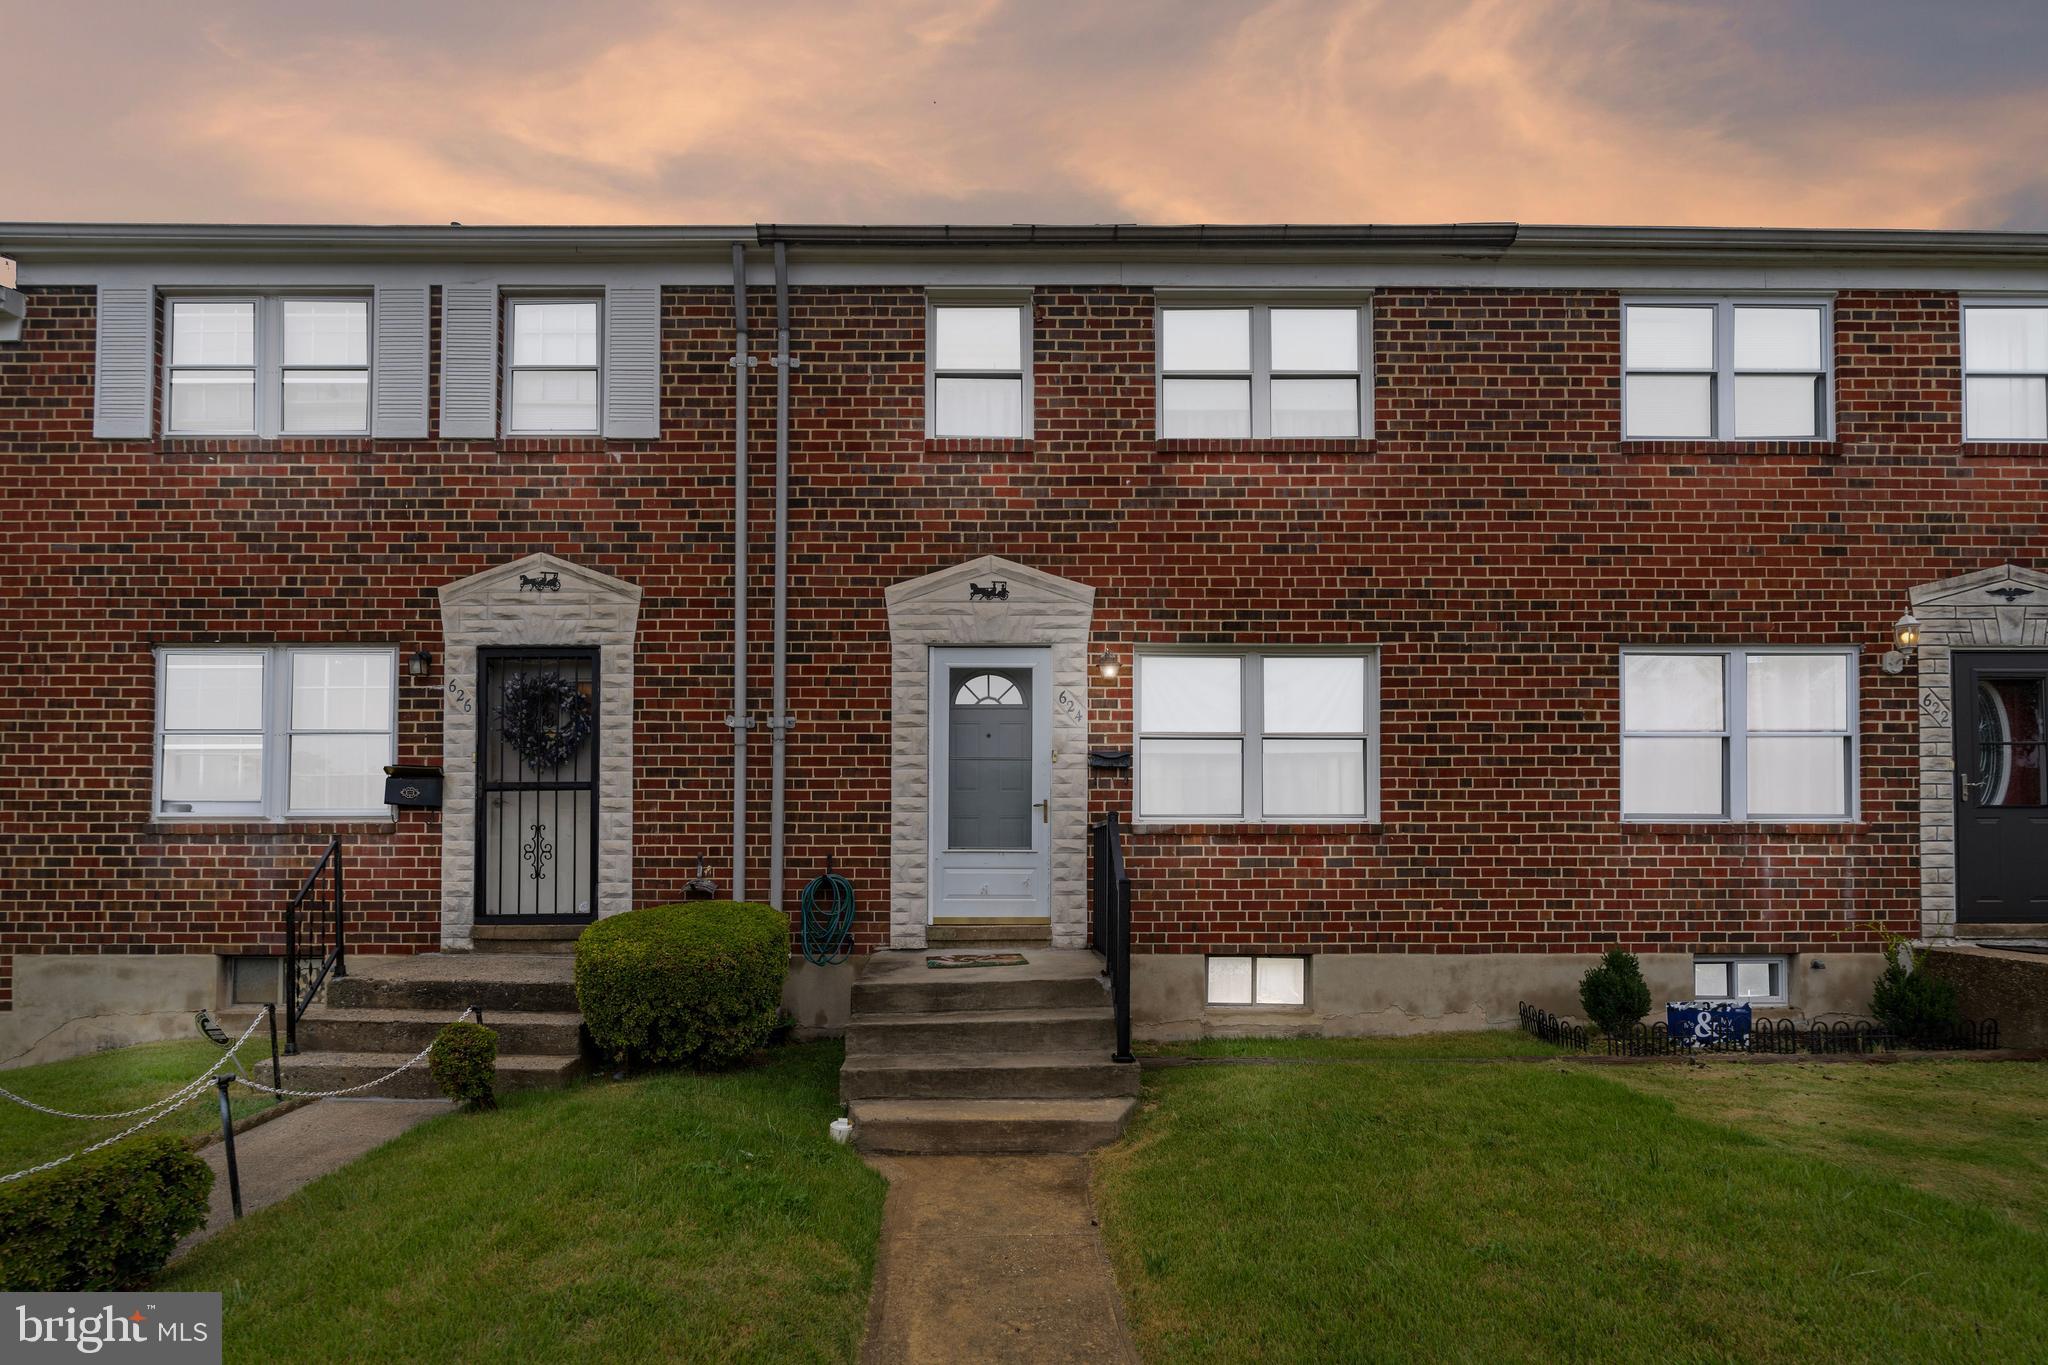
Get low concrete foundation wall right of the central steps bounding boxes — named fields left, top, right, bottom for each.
left=1130, top=954, right=1884, bottom=1042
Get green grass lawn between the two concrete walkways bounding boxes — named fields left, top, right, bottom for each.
left=158, top=1044, right=885, bottom=1361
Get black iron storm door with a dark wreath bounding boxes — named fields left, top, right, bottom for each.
left=477, top=649, right=600, bottom=925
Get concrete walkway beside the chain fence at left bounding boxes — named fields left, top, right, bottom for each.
left=172, top=1099, right=455, bottom=1261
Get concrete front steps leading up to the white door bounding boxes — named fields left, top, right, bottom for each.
left=840, top=943, right=1139, bottom=1154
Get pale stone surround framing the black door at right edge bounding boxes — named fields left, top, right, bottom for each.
left=1911, top=565, right=2048, bottom=939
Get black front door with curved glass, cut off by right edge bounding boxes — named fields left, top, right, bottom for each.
left=1956, top=653, right=2048, bottom=925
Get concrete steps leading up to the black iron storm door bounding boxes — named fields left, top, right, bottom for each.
left=285, top=945, right=584, bottom=1099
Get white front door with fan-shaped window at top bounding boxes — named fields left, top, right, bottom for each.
left=932, top=649, right=1053, bottom=923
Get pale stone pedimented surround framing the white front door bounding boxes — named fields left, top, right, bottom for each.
left=885, top=555, right=1096, bottom=948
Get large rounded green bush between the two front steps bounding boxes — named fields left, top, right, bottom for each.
left=575, top=900, right=788, bottom=1070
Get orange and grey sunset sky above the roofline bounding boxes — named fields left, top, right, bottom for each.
left=16, top=0, right=2048, bottom=229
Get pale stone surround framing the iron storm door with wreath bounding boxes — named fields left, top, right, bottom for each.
left=440, top=555, right=641, bottom=950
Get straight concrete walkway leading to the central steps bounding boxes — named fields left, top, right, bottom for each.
left=860, top=1156, right=1137, bottom=1365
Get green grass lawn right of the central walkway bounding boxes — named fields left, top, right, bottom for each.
left=1096, top=1048, right=2048, bottom=1361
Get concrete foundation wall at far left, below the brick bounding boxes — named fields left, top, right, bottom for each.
left=0, top=954, right=221, bottom=1066
